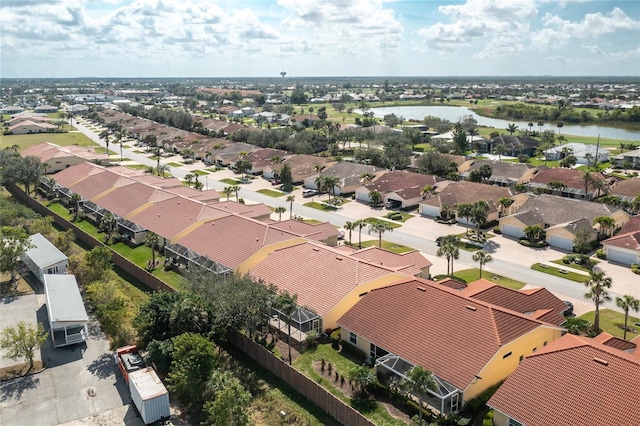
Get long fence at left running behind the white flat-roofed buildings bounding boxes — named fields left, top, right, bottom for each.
left=5, top=183, right=176, bottom=293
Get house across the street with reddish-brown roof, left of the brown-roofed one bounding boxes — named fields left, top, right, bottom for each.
left=356, top=170, right=437, bottom=208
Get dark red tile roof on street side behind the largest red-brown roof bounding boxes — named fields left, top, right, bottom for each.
left=461, top=279, right=567, bottom=325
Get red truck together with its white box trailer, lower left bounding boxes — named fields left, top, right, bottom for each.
left=114, top=346, right=171, bottom=425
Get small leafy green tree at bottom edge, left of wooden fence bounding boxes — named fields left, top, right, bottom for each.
left=201, top=371, right=251, bottom=426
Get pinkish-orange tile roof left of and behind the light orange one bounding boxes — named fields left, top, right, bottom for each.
left=174, top=215, right=299, bottom=268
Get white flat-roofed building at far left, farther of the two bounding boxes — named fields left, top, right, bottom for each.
left=20, top=234, right=69, bottom=283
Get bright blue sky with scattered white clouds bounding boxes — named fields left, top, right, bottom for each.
left=0, top=0, right=640, bottom=78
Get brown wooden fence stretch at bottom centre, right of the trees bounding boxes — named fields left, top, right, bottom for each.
left=228, top=332, right=375, bottom=426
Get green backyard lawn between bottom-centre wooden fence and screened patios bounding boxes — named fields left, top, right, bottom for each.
left=293, top=344, right=405, bottom=426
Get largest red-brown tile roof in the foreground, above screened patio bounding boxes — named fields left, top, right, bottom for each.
left=338, top=279, right=556, bottom=389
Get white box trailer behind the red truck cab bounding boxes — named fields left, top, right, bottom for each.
left=129, top=367, right=171, bottom=425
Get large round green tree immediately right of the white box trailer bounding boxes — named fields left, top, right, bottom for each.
left=167, top=333, right=217, bottom=404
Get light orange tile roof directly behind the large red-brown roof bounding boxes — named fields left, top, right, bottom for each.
left=249, top=242, right=402, bottom=316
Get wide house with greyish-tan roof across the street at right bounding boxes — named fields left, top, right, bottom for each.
left=500, top=194, right=629, bottom=250
